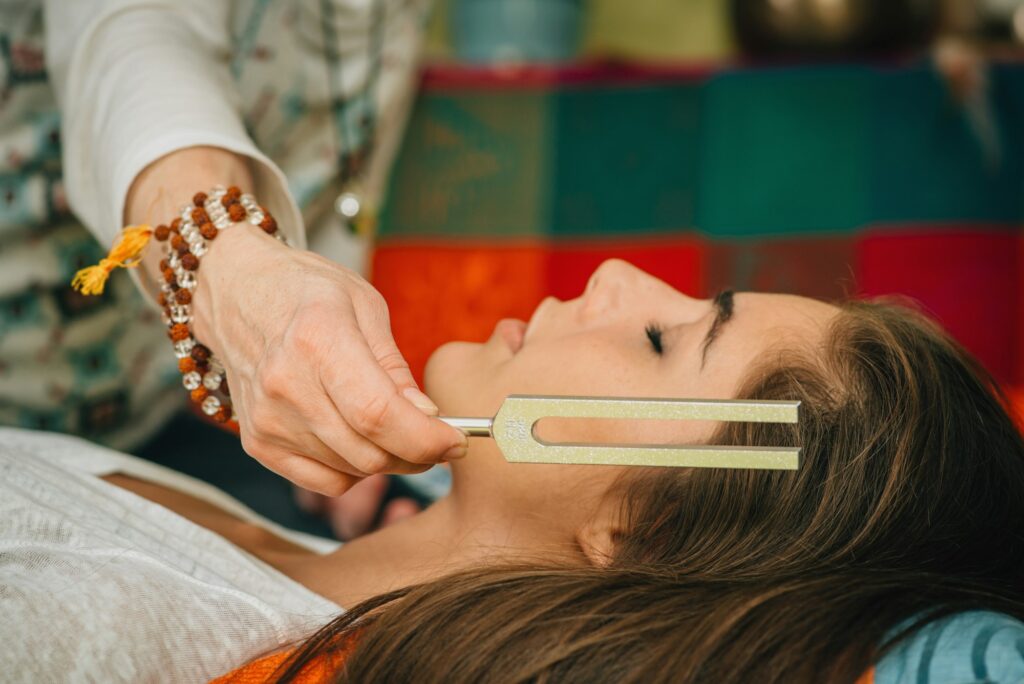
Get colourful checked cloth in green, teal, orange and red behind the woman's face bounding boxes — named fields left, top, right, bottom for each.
left=373, top=65, right=1024, bottom=385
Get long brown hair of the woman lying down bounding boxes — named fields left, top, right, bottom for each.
left=280, top=302, right=1024, bottom=682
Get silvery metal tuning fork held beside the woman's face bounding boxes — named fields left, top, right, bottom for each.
left=440, top=394, right=800, bottom=470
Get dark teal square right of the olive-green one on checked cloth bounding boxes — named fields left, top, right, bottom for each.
left=549, top=82, right=700, bottom=236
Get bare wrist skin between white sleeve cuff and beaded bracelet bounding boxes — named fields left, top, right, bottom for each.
left=124, top=147, right=253, bottom=299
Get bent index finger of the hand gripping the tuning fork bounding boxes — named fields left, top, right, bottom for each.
left=321, top=328, right=468, bottom=463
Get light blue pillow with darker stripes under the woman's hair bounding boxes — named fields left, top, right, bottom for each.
left=873, top=610, right=1024, bottom=684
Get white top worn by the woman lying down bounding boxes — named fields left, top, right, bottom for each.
left=0, top=428, right=341, bottom=682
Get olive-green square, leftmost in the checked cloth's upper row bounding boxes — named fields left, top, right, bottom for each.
left=380, top=90, right=551, bottom=238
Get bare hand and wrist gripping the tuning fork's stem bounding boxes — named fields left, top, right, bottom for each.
left=125, top=147, right=467, bottom=496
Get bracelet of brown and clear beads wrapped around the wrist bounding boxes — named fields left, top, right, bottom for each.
left=153, top=185, right=288, bottom=427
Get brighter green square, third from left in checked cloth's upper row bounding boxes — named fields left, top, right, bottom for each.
left=696, top=67, right=871, bottom=236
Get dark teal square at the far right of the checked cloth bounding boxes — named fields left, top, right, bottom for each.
left=871, top=67, right=1024, bottom=222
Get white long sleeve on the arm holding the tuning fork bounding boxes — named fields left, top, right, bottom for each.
left=45, top=0, right=305, bottom=247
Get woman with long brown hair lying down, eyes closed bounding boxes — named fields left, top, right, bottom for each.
left=0, top=261, right=1024, bottom=684
